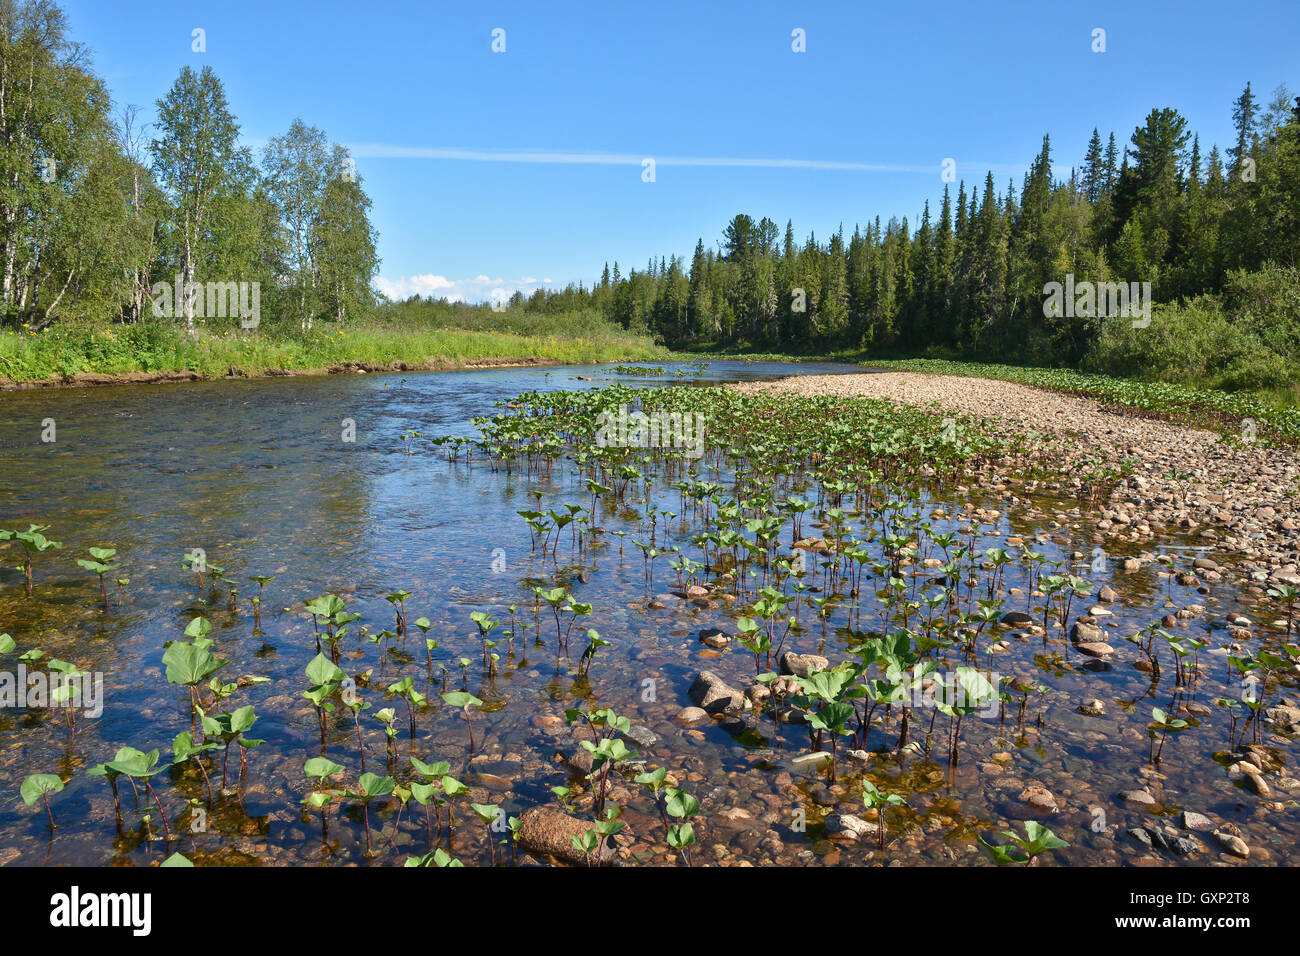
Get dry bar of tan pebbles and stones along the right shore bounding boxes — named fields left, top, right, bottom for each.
left=735, top=371, right=1300, bottom=584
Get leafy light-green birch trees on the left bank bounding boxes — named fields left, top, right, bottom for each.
left=0, top=0, right=378, bottom=332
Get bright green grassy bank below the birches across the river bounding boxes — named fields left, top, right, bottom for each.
left=0, top=323, right=668, bottom=385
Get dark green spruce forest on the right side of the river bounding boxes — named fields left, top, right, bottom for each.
left=504, top=85, right=1300, bottom=382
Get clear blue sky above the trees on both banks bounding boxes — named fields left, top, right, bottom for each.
left=64, top=0, right=1300, bottom=300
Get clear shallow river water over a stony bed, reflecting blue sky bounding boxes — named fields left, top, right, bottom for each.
left=0, top=362, right=1300, bottom=865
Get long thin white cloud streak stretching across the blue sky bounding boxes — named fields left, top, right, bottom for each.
left=348, top=143, right=1024, bottom=176
